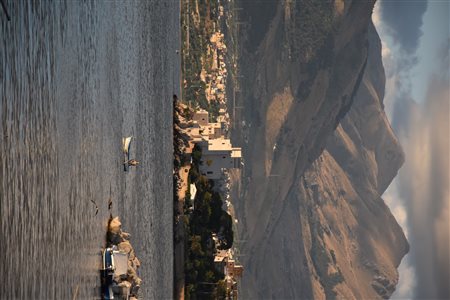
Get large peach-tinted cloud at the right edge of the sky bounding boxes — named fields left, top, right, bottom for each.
left=399, top=75, right=450, bottom=299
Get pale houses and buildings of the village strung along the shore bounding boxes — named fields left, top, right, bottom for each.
left=184, top=21, right=243, bottom=299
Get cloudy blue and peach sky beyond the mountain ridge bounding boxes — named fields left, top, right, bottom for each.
left=373, top=0, right=450, bottom=299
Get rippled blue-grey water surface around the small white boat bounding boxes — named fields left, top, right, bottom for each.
left=0, top=0, right=179, bottom=299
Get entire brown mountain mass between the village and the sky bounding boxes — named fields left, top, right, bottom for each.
left=230, top=1, right=408, bottom=299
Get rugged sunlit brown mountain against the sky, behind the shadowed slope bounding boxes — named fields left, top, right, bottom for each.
left=298, top=27, right=408, bottom=299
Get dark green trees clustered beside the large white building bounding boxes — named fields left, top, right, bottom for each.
left=184, top=146, right=233, bottom=299
